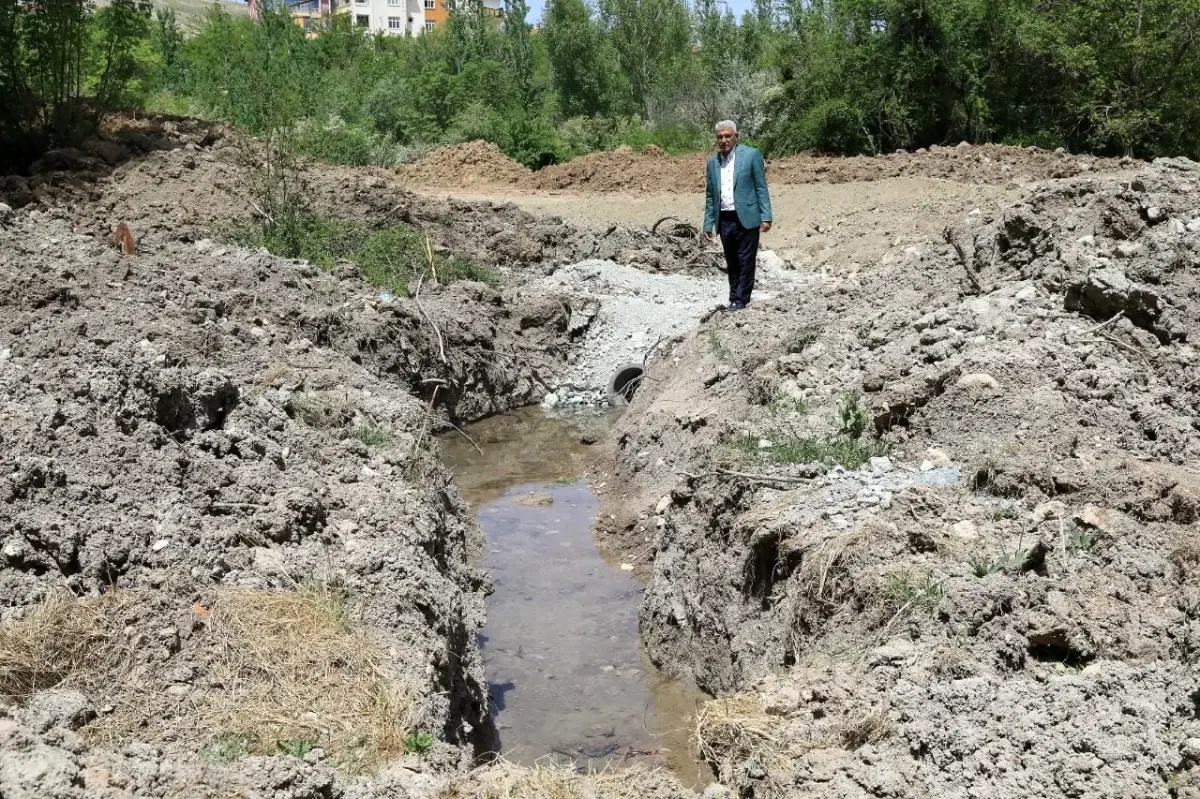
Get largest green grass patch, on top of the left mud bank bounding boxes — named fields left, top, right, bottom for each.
left=228, top=215, right=499, bottom=296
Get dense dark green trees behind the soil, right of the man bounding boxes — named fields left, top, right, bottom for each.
left=763, top=0, right=1200, bottom=155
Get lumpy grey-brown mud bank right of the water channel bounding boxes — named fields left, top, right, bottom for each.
left=611, top=160, right=1200, bottom=797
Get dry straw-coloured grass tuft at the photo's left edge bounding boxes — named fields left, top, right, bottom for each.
left=0, top=591, right=134, bottom=702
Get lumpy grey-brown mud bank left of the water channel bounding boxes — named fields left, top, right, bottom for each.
left=0, top=125, right=705, bottom=799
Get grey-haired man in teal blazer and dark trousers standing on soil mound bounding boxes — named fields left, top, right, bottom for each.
left=704, top=120, right=772, bottom=311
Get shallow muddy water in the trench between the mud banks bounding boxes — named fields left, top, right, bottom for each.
left=442, top=408, right=706, bottom=785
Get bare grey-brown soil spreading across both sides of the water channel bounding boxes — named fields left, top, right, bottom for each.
left=0, top=118, right=1200, bottom=799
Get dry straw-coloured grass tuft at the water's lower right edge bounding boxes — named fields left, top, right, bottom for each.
left=692, top=693, right=790, bottom=779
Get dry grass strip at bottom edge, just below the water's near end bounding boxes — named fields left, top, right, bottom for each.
left=439, top=759, right=689, bottom=799
